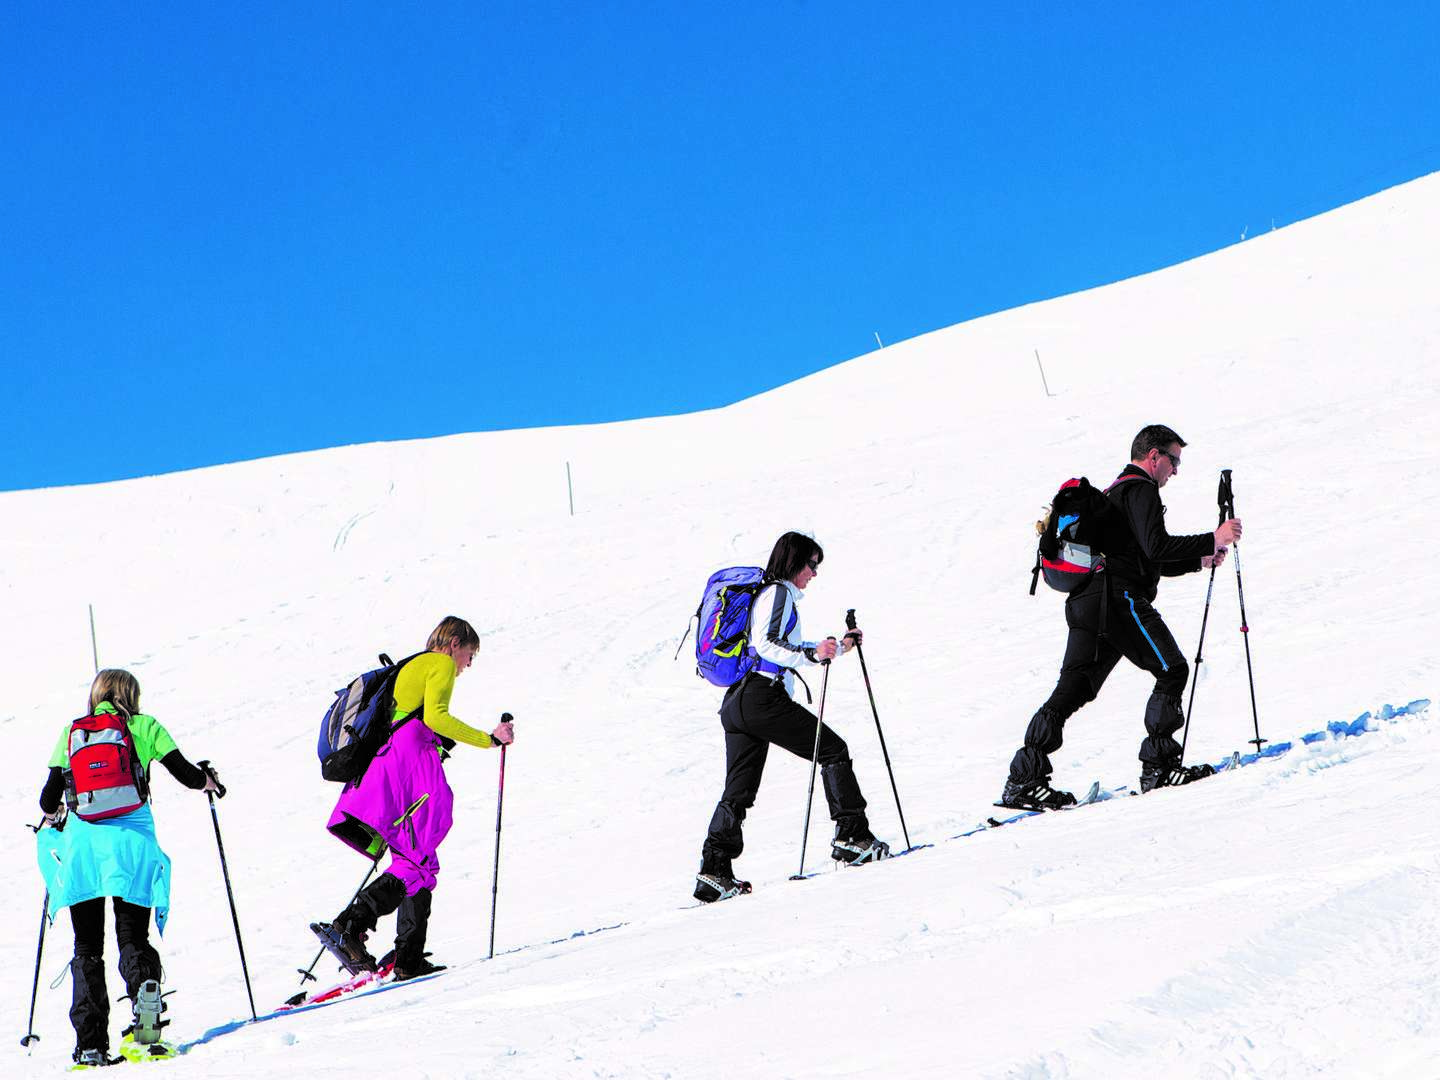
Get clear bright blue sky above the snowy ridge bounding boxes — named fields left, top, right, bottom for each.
left=0, top=0, right=1440, bottom=490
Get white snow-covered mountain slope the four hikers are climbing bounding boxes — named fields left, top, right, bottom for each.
left=0, top=176, right=1440, bottom=1080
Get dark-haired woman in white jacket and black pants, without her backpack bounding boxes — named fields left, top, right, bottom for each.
left=696, top=533, right=890, bottom=903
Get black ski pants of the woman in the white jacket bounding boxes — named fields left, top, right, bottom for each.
left=700, top=674, right=870, bottom=877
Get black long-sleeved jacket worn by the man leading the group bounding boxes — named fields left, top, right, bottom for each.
left=1104, top=465, right=1215, bottom=600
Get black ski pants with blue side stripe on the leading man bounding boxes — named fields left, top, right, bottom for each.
left=1009, top=577, right=1189, bottom=785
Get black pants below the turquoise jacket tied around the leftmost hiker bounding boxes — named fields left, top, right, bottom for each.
left=71, top=896, right=160, bottom=1051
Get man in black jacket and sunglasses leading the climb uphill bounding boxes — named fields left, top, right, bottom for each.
left=1001, top=423, right=1241, bottom=809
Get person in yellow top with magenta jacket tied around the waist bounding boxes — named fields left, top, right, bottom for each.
left=314, top=615, right=514, bottom=979
